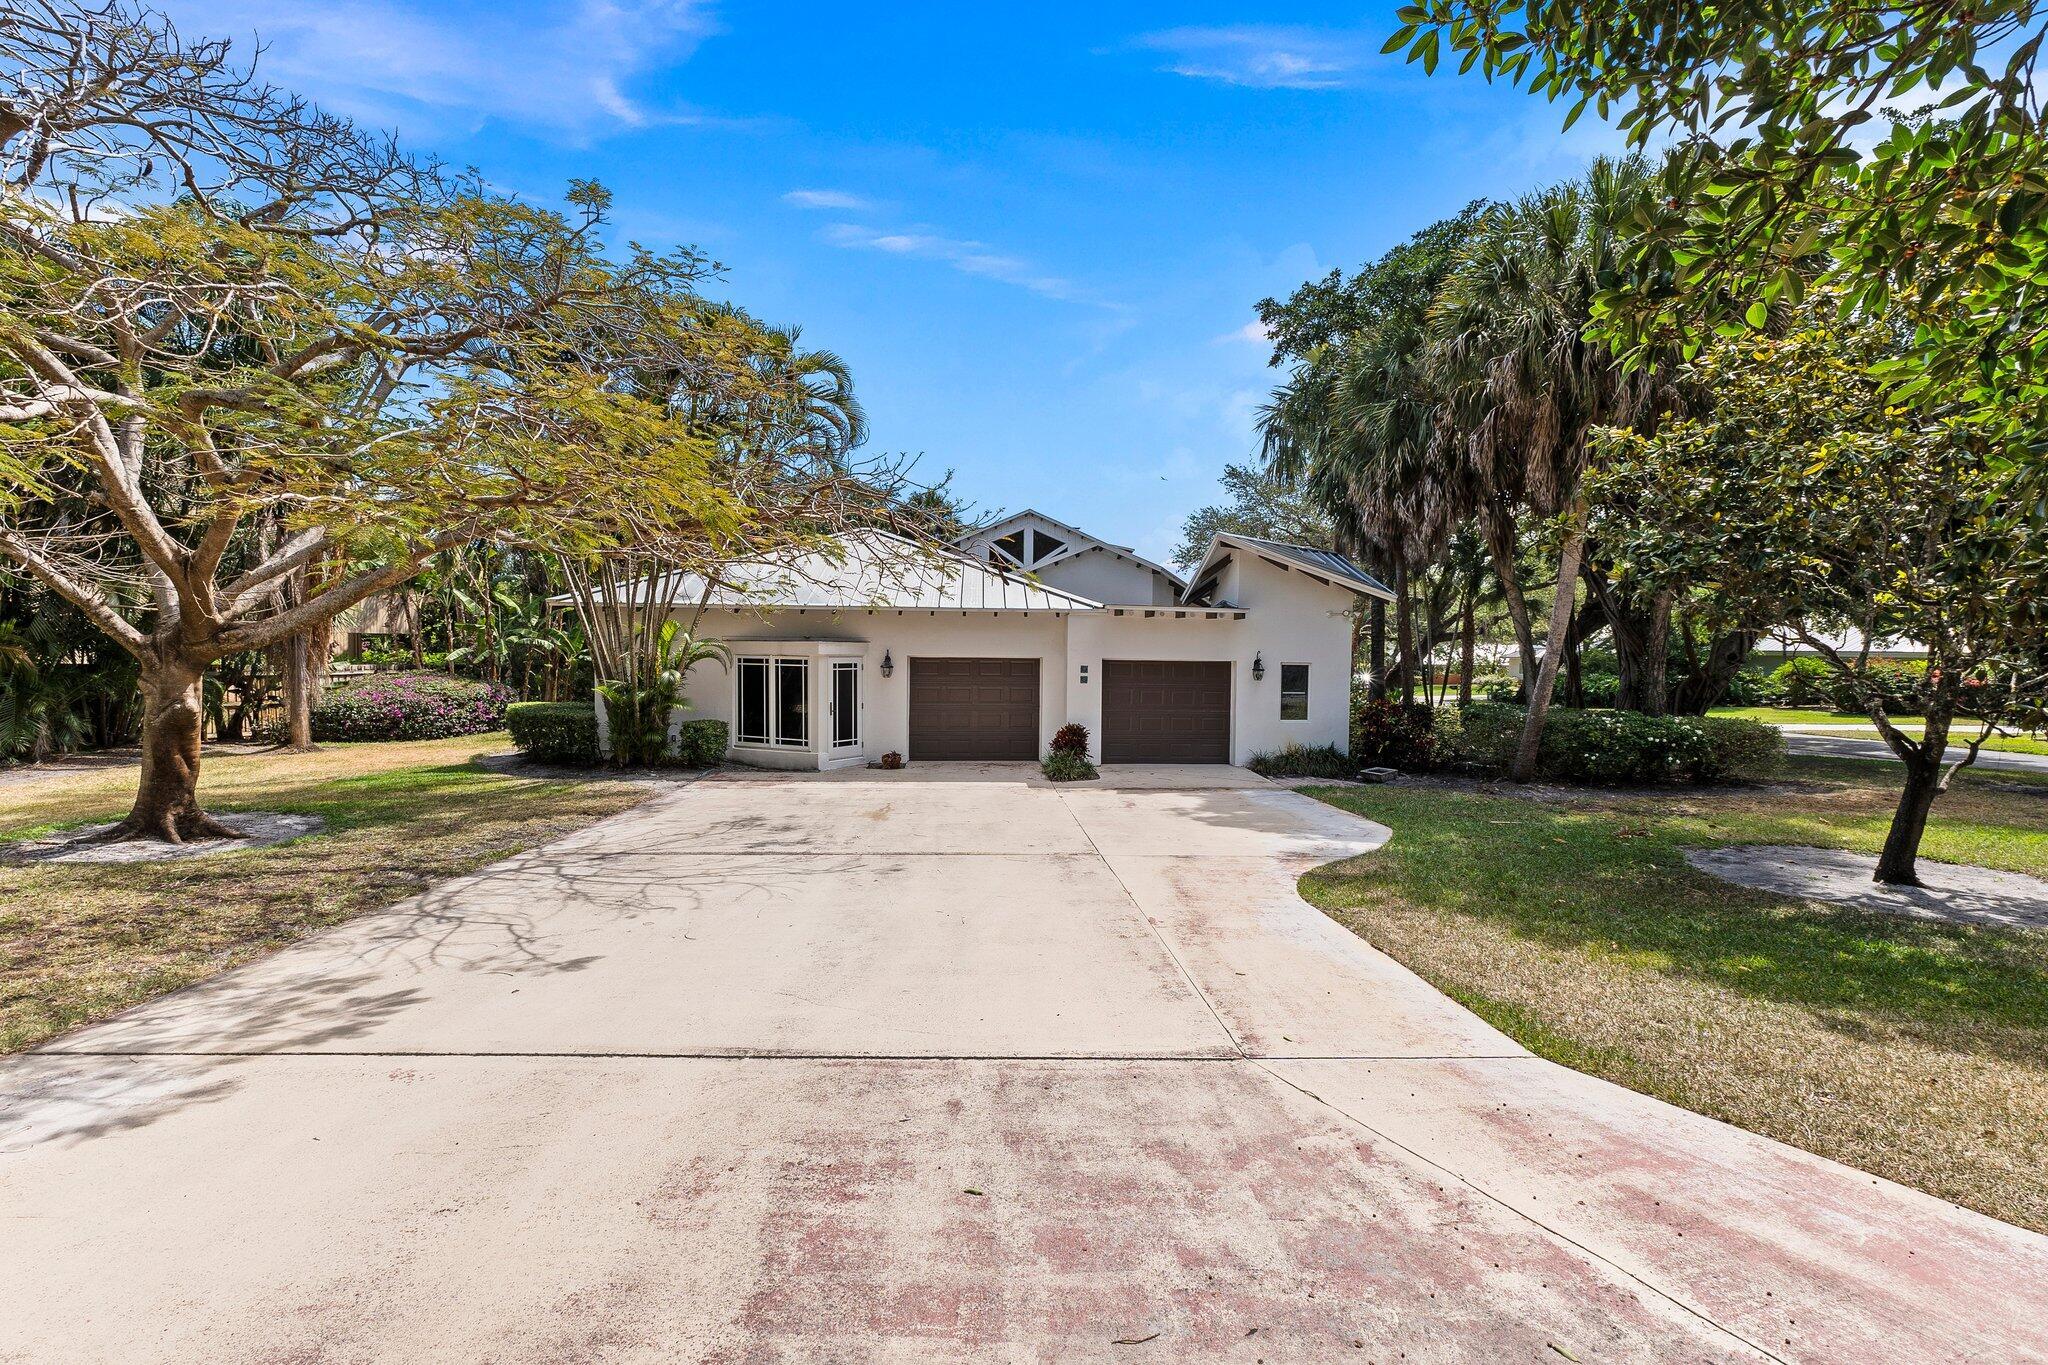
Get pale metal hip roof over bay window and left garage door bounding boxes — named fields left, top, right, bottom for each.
left=555, top=530, right=1100, bottom=612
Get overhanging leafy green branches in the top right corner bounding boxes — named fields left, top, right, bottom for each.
left=1389, top=0, right=2048, bottom=467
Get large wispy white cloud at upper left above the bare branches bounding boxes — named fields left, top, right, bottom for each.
left=168, top=0, right=715, bottom=137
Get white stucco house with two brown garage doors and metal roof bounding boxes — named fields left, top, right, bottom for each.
left=606, top=512, right=1391, bottom=767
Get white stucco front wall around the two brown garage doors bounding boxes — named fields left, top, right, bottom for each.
left=684, top=555, right=1358, bottom=767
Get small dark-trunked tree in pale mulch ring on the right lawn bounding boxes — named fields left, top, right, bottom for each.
left=1597, top=299, right=2048, bottom=884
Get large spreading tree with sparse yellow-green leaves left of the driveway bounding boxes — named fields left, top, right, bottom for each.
left=0, top=4, right=729, bottom=841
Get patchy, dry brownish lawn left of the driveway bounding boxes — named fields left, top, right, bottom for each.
left=0, top=735, right=649, bottom=1052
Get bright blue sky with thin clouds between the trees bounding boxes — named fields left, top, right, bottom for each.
left=170, top=0, right=1614, bottom=557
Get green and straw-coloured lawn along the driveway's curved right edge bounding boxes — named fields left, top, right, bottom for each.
left=1303, top=759, right=2048, bottom=1230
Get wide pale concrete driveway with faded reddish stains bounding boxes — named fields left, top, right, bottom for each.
left=0, top=765, right=2048, bottom=1361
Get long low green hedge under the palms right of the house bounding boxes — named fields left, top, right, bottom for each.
left=1446, top=702, right=1784, bottom=786
